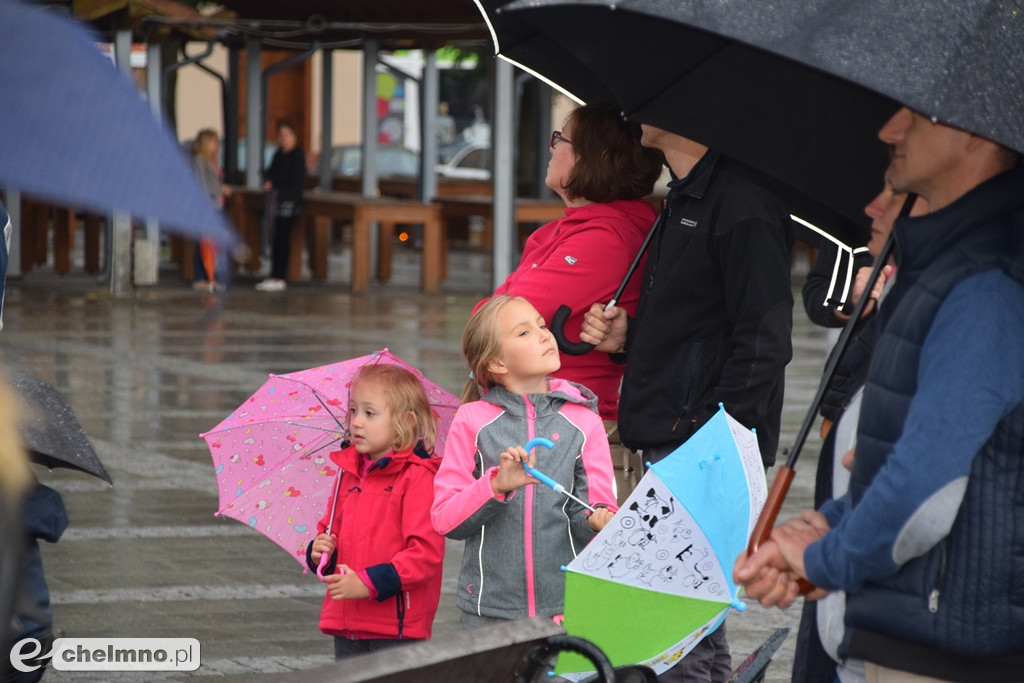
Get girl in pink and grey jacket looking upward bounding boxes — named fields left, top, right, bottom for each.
left=431, top=296, right=615, bottom=626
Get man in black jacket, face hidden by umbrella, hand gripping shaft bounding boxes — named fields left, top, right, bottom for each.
left=580, top=125, right=793, bottom=682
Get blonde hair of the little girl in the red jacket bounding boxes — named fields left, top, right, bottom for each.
left=352, top=364, right=437, bottom=453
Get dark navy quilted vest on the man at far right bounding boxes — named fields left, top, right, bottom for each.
left=841, top=168, right=1024, bottom=680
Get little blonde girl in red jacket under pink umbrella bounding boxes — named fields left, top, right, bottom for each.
left=306, top=365, right=444, bottom=659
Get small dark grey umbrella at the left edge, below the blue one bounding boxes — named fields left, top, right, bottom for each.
left=3, top=369, right=114, bottom=483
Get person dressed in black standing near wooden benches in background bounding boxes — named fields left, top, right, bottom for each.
left=256, top=119, right=306, bottom=292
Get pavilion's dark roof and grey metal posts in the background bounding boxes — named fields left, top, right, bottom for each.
left=37, top=0, right=550, bottom=284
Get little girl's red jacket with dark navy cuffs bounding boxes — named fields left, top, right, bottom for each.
left=307, top=447, right=444, bottom=638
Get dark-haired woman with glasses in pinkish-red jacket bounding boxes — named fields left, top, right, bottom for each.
left=476, top=104, right=662, bottom=503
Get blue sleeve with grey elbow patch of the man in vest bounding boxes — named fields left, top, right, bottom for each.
left=804, top=270, right=1024, bottom=592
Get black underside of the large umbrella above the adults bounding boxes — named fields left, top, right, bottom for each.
left=494, top=0, right=913, bottom=243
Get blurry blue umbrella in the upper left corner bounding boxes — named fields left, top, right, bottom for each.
left=0, top=0, right=234, bottom=245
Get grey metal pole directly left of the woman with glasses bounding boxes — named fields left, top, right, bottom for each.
left=490, top=59, right=516, bottom=289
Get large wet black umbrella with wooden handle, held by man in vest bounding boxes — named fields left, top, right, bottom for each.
left=495, top=0, right=1024, bottom=561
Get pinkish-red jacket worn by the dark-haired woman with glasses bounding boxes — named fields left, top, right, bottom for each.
left=487, top=200, right=657, bottom=420
